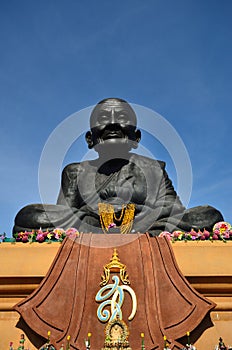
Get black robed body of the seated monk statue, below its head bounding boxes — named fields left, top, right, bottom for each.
left=13, top=154, right=223, bottom=235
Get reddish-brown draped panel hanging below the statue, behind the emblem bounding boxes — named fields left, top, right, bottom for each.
left=15, top=234, right=215, bottom=350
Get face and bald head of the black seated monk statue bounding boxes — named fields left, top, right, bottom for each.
left=86, top=99, right=138, bottom=149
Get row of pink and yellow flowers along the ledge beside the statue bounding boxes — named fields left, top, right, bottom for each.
left=0, top=221, right=232, bottom=243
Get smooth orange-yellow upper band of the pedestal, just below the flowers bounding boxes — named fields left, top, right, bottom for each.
left=0, top=241, right=232, bottom=277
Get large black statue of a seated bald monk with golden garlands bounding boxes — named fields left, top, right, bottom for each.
left=13, top=98, right=223, bottom=236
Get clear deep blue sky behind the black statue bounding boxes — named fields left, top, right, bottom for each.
left=0, top=0, right=232, bottom=236
